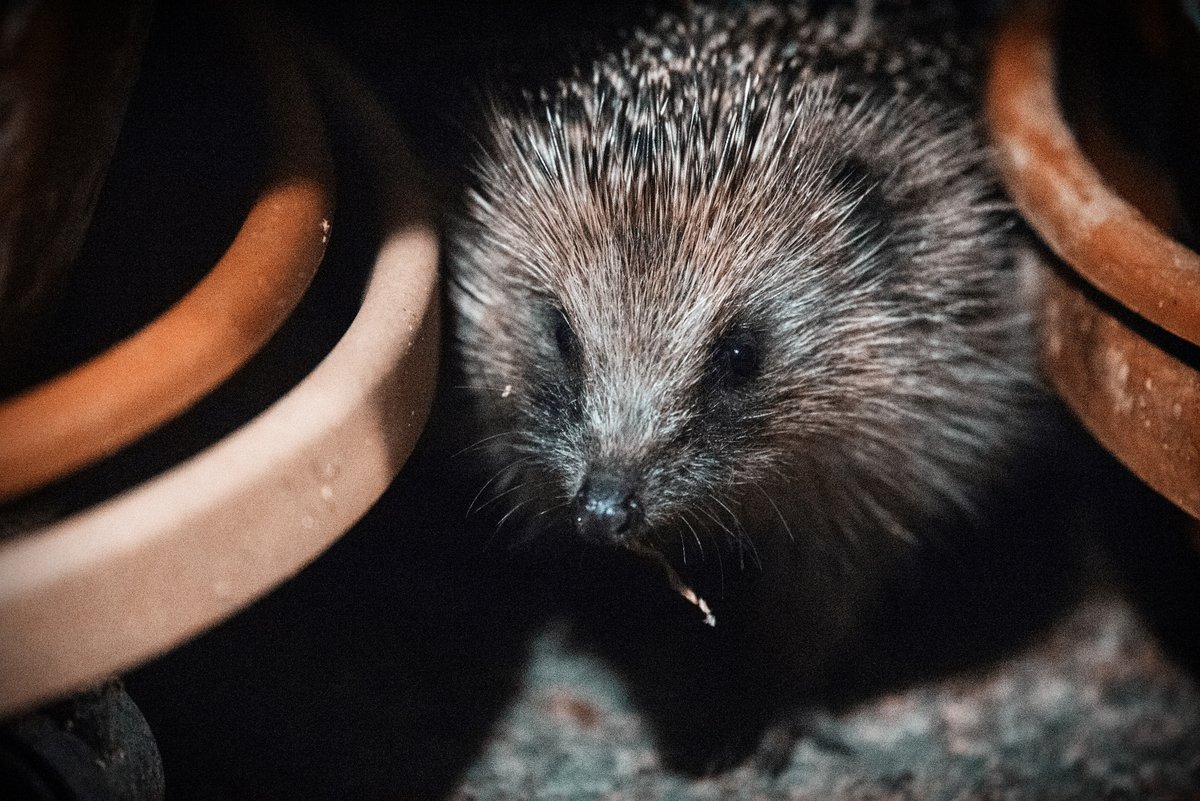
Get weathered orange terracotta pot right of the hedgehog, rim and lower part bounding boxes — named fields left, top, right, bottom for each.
left=988, top=2, right=1200, bottom=518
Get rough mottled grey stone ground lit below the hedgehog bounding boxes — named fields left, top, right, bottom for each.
left=451, top=596, right=1200, bottom=801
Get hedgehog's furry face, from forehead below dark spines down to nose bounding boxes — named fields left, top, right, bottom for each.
left=452, top=172, right=854, bottom=553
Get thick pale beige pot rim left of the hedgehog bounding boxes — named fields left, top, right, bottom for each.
left=0, top=15, right=439, bottom=716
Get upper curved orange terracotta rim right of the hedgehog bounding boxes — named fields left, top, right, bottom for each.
left=985, top=0, right=1200, bottom=343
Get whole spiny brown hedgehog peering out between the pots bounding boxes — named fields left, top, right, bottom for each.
left=446, top=2, right=1042, bottom=762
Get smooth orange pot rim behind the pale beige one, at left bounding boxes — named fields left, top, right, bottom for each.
left=0, top=6, right=334, bottom=501
